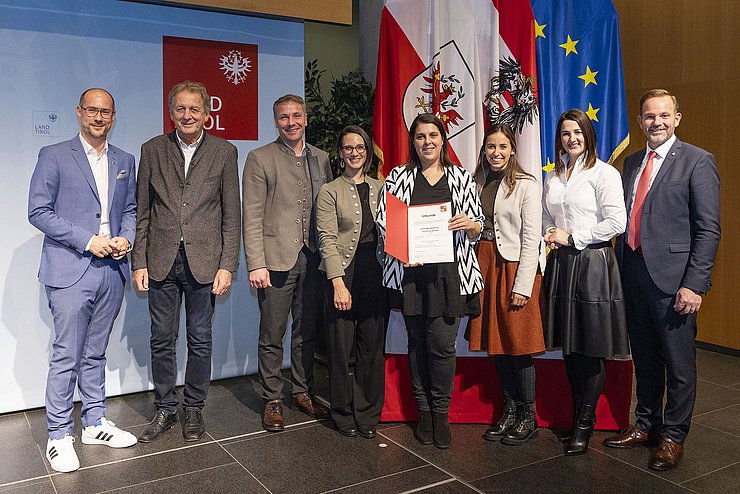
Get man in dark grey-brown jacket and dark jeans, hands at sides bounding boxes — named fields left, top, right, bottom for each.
left=132, top=81, right=241, bottom=443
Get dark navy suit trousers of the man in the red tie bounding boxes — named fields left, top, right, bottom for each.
left=622, top=247, right=696, bottom=444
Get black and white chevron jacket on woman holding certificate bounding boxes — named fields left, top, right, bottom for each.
left=376, top=165, right=483, bottom=295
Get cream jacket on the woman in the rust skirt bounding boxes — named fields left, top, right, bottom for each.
left=484, top=176, right=542, bottom=297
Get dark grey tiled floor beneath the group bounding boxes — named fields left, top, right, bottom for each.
left=0, top=350, right=740, bottom=494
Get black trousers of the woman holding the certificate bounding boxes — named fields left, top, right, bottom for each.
left=403, top=316, right=460, bottom=413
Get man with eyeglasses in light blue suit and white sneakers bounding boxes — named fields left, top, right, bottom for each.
left=28, top=88, right=136, bottom=472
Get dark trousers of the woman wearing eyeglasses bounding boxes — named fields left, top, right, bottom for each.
left=326, top=244, right=388, bottom=427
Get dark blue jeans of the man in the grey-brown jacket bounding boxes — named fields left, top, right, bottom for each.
left=148, top=248, right=216, bottom=412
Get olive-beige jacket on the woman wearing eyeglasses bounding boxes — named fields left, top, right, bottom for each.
left=316, top=175, right=385, bottom=280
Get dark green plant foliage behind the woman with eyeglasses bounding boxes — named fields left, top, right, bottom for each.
left=305, top=60, right=378, bottom=177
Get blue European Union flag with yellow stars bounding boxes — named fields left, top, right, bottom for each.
left=532, top=0, right=629, bottom=176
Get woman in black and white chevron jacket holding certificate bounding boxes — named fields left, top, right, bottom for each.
left=378, top=114, right=483, bottom=448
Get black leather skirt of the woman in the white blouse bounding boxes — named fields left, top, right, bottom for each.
left=543, top=242, right=629, bottom=358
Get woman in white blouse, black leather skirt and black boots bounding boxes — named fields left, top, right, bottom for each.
left=542, top=109, right=629, bottom=455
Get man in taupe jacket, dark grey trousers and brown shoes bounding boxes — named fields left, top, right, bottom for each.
left=242, top=94, right=332, bottom=431
